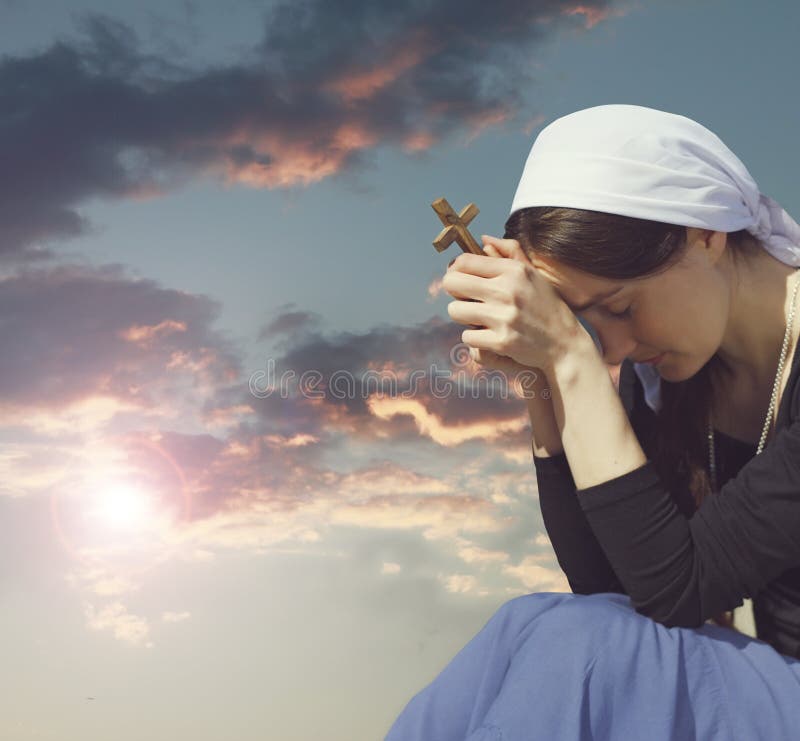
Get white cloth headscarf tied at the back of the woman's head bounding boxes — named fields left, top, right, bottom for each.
left=509, top=104, right=800, bottom=411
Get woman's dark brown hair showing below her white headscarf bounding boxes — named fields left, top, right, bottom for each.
left=504, top=206, right=761, bottom=629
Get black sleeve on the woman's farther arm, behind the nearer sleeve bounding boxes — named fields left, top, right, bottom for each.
left=533, top=361, right=644, bottom=594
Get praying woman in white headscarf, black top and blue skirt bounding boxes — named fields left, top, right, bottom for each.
left=386, top=105, right=800, bottom=741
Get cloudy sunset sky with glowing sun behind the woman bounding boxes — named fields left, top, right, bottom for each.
left=0, top=0, right=800, bottom=741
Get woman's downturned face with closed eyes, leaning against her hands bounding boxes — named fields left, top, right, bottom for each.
left=531, top=228, right=729, bottom=381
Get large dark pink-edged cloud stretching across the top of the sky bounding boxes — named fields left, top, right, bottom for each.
left=0, top=0, right=610, bottom=261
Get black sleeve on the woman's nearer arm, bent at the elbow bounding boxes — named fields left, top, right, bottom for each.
left=576, top=384, right=800, bottom=627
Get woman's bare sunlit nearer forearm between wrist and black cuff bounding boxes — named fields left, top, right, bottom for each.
left=537, top=338, right=647, bottom=490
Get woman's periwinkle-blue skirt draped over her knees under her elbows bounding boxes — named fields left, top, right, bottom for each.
left=385, top=592, right=800, bottom=741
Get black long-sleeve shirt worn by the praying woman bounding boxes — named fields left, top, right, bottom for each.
left=534, top=352, right=800, bottom=658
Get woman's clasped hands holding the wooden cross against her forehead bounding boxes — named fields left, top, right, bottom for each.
left=442, top=236, right=586, bottom=370
